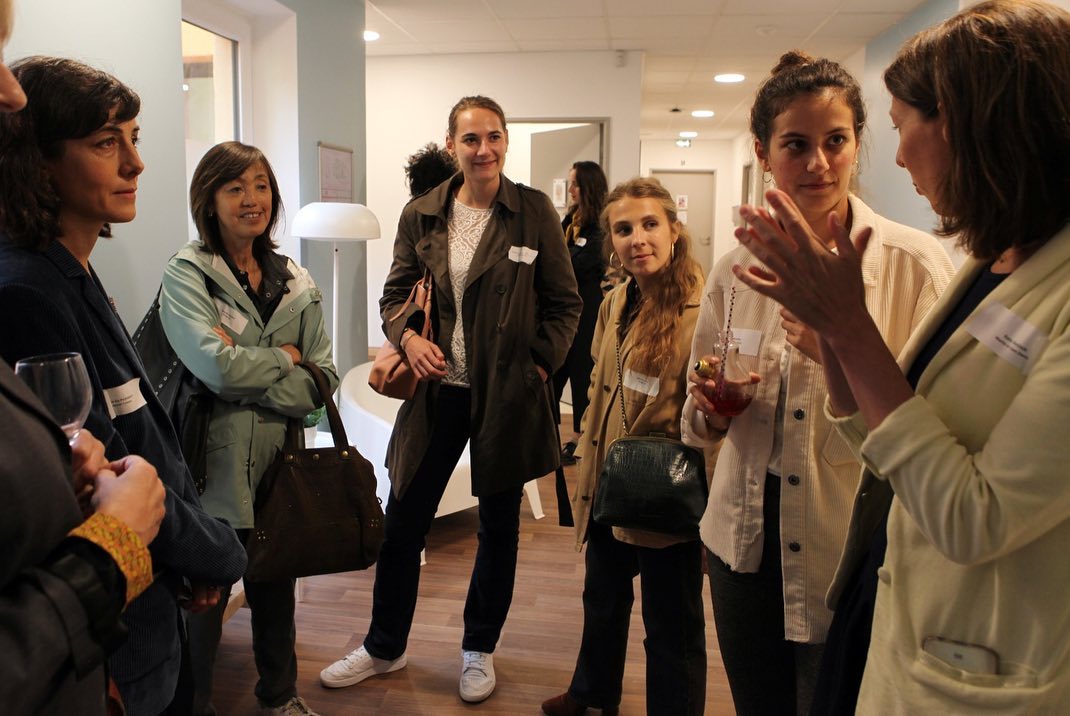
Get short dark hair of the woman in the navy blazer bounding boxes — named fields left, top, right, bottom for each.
left=0, top=56, right=141, bottom=250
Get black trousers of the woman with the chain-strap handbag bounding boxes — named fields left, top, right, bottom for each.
left=568, top=521, right=706, bottom=716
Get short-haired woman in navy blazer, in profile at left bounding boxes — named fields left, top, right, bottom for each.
left=0, top=57, right=245, bottom=716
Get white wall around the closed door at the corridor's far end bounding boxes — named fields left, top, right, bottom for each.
left=640, top=139, right=743, bottom=265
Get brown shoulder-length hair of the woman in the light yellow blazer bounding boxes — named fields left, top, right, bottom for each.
left=884, top=0, right=1070, bottom=260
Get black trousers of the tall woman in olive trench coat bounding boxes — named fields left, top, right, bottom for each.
left=364, top=385, right=523, bottom=659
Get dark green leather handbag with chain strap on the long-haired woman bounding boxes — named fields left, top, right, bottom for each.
left=593, top=338, right=709, bottom=539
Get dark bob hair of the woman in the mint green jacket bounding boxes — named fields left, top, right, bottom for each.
left=189, top=141, right=282, bottom=257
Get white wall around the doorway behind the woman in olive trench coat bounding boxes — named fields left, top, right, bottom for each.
left=367, top=51, right=642, bottom=347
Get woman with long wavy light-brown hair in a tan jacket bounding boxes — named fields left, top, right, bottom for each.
left=542, top=179, right=706, bottom=716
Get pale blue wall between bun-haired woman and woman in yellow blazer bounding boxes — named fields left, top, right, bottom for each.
left=859, top=0, right=959, bottom=257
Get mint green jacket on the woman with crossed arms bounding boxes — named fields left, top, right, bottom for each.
left=159, top=242, right=338, bottom=529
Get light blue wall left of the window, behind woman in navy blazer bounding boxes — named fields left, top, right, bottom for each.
left=5, top=0, right=186, bottom=326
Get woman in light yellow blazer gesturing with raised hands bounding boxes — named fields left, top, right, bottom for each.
left=735, top=0, right=1070, bottom=714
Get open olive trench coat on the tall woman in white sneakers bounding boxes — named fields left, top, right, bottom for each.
left=379, top=173, right=582, bottom=497
